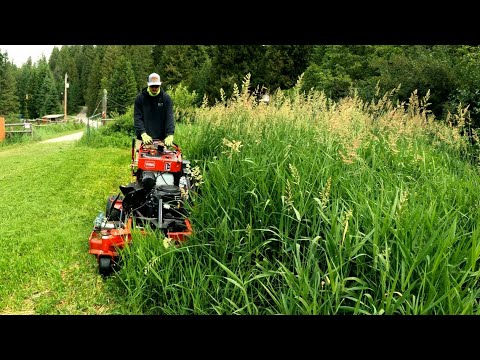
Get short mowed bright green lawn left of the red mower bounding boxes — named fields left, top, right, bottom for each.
left=0, top=142, right=131, bottom=314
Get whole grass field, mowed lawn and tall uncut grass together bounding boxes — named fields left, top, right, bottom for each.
left=0, top=77, right=480, bottom=315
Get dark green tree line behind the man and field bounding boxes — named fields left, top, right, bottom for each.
left=0, top=45, right=480, bottom=128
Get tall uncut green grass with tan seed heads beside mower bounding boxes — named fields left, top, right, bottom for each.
left=110, top=78, right=480, bottom=315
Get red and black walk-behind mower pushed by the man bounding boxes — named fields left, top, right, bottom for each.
left=89, top=138, right=195, bottom=276
